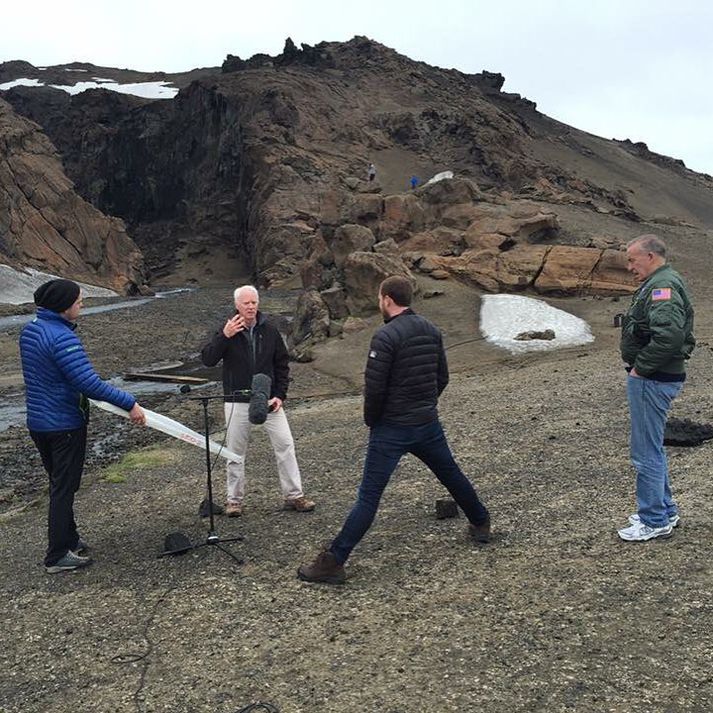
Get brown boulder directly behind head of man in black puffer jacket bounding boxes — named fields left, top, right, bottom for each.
left=343, top=252, right=416, bottom=316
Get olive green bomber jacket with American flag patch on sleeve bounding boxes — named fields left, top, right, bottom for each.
left=620, top=264, right=696, bottom=378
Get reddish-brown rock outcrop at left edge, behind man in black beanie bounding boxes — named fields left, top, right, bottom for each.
left=0, top=99, right=145, bottom=294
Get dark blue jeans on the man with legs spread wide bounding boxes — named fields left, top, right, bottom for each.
left=330, top=420, right=488, bottom=564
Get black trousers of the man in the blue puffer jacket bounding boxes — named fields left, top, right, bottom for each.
left=30, top=426, right=87, bottom=567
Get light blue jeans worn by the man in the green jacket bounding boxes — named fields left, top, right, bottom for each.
left=626, top=376, right=683, bottom=527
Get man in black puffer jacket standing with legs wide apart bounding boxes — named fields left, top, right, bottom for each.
left=297, top=276, right=490, bottom=584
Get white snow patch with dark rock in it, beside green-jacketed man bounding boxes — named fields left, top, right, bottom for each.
left=480, top=295, right=594, bottom=354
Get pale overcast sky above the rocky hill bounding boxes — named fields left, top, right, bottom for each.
left=5, top=0, right=713, bottom=174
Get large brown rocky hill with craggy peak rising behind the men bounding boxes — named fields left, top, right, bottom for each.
left=0, top=37, right=713, bottom=302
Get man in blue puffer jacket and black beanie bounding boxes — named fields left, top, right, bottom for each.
left=20, top=279, right=146, bottom=573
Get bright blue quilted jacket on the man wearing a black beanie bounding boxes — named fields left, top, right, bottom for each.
left=20, top=307, right=136, bottom=431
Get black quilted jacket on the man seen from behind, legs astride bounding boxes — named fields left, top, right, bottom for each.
left=364, top=309, right=448, bottom=427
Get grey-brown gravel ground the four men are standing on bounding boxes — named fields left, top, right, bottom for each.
left=0, top=284, right=713, bottom=713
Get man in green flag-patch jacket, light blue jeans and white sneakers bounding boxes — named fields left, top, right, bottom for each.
left=619, top=235, right=696, bottom=542
